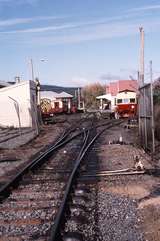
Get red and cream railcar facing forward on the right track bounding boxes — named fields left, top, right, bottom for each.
left=116, top=90, right=137, bottom=117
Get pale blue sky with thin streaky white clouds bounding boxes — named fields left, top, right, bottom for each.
left=0, top=0, right=160, bottom=86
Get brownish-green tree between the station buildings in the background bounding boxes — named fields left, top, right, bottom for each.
left=82, top=82, right=106, bottom=108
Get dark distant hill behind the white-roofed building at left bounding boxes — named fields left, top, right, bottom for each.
left=41, top=85, right=78, bottom=96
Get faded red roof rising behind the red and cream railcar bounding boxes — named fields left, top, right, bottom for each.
left=106, top=80, right=138, bottom=96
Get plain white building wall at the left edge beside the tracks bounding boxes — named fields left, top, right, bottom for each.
left=0, top=81, right=38, bottom=130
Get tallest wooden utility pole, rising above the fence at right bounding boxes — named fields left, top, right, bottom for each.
left=139, top=27, right=144, bottom=87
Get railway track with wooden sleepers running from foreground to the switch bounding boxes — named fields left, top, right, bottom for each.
left=0, top=117, right=122, bottom=241
